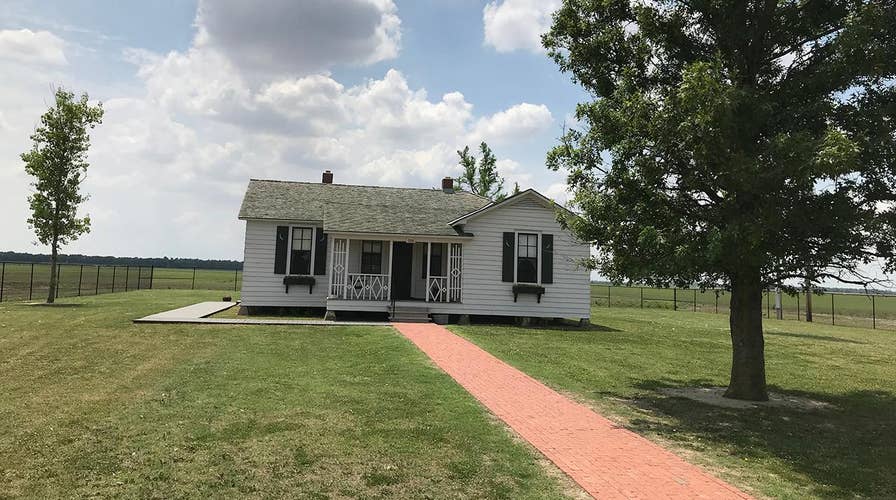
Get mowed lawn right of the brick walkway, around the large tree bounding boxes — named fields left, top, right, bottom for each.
left=451, top=308, right=896, bottom=498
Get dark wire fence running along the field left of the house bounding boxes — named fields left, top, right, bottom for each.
left=0, top=262, right=242, bottom=302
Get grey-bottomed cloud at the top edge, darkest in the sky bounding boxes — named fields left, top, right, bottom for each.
left=196, top=0, right=401, bottom=75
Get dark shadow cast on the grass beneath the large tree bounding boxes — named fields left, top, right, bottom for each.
left=629, top=380, right=896, bottom=498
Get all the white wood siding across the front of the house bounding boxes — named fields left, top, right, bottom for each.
left=241, top=193, right=591, bottom=318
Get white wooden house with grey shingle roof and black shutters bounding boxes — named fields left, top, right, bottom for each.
left=239, top=171, right=590, bottom=321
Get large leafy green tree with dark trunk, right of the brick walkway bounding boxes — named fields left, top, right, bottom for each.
left=543, top=0, right=896, bottom=400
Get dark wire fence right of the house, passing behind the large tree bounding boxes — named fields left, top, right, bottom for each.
left=591, top=284, right=896, bottom=330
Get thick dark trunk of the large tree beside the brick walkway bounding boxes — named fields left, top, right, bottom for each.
left=725, top=271, right=768, bottom=401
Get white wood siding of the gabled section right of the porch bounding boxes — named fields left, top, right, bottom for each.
left=457, top=199, right=591, bottom=318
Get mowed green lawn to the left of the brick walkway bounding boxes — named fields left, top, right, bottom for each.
left=0, top=291, right=565, bottom=498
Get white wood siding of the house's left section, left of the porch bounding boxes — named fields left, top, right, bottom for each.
left=240, top=220, right=328, bottom=307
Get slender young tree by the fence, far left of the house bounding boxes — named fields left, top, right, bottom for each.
left=22, top=88, right=103, bottom=304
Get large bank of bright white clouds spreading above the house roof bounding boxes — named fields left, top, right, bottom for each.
left=0, top=0, right=568, bottom=258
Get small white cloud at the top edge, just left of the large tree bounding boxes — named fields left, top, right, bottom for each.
left=482, top=0, right=560, bottom=52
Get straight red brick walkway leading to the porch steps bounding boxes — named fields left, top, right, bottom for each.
left=394, top=323, right=750, bottom=499
